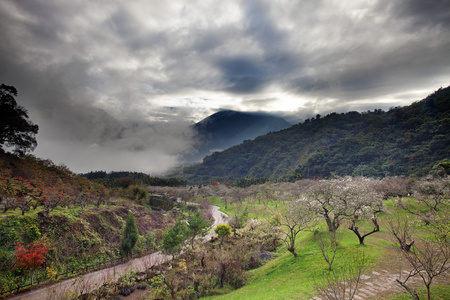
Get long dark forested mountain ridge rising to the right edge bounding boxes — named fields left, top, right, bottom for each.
left=182, top=87, right=450, bottom=181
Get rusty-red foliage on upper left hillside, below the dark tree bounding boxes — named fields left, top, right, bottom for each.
left=0, top=152, right=107, bottom=214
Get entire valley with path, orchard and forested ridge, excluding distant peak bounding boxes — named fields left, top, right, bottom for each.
left=0, top=87, right=450, bottom=300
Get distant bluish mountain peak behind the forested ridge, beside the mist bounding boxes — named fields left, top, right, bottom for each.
left=186, top=110, right=291, bottom=161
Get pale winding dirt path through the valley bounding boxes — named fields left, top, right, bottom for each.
left=7, top=203, right=227, bottom=300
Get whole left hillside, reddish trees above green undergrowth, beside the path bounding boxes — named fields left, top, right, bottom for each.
left=0, top=150, right=170, bottom=296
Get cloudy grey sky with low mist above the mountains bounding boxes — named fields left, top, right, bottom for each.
left=0, top=0, right=450, bottom=175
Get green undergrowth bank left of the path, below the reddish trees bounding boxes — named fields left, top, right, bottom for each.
left=0, top=203, right=166, bottom=291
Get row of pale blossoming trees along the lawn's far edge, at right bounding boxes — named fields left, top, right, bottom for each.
left=273, top=177, right=450, bottom=255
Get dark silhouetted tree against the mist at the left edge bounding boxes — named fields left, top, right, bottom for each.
left=0, top=84, right=39, bottom=155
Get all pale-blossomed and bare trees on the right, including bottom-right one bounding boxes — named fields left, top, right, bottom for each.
left=264, top=177, right=450, bottom=300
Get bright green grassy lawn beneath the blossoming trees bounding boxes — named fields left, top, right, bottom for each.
left=206, top=230, right=385, bottom=299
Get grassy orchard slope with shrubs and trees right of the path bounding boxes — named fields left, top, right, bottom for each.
left=67, top=178, right=450, bottom=299
